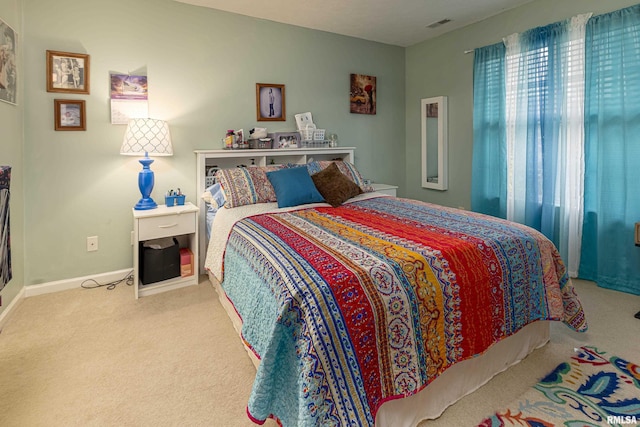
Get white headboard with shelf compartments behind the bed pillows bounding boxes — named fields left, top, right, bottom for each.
left=194, top=147, right=355, bottom=274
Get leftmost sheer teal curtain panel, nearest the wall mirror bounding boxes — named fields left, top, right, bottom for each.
left=471, top=43, right=507, bottom=218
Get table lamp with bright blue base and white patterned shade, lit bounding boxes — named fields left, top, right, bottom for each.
left=120, top=119, right=173, bottom=210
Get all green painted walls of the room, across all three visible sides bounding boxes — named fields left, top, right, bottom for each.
left=0, top=0, right=636, bottom=312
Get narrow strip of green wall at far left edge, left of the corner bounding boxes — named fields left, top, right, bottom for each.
left=0, top=0, right=25, bottom=313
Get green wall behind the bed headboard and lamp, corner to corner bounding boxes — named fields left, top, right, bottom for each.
left=23, top=0, right=405, bottom=285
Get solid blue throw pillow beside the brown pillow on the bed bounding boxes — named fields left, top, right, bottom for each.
left=267, top=166, right=324, bottom=208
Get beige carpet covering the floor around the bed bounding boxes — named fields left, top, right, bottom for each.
left=0, top=280, right=640, bottom=427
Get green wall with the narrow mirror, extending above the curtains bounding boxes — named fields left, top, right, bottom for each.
left=402, top=0, right=638, bottom=209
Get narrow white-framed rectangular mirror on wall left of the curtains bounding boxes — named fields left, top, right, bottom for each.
left=420, top=96, right=447, bottom=190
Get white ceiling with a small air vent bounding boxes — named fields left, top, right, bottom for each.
left=176, top=0, right=533, bottom=47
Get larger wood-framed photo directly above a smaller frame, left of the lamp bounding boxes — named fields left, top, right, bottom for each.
left=47, top=50, right=89, bottom=95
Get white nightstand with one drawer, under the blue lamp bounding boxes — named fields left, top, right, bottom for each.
left=132, top=202, right=198, bottom=299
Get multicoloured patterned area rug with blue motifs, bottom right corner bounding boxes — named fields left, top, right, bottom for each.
left=478, top=347, right=640, bottom=427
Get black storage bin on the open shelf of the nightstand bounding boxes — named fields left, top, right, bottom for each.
left=139, top=238, right=180, bottom=285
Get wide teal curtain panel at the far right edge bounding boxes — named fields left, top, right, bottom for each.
left=579, top=5, right=640, bottom=295
